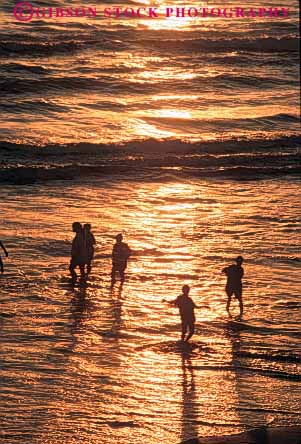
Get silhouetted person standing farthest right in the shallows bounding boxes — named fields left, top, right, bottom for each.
left=222, top=256, right=244, bottom=316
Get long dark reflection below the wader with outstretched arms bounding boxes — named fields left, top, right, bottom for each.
left=181, top=350, right=198, bottom=441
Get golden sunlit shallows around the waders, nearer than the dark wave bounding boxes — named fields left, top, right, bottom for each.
left=0, top=179, right=301, bottom=444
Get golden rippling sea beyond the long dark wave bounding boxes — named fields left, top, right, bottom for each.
left=0, top=0, right=300, bottom=146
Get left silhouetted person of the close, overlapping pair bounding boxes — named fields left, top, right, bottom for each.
left=69, top=222, right=86, bottom=284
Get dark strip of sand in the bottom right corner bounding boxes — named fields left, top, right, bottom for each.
left=182, top=427, right=301, bottom=444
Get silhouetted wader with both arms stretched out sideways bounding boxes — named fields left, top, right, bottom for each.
left=163, top=285, right=201, bottom=342
